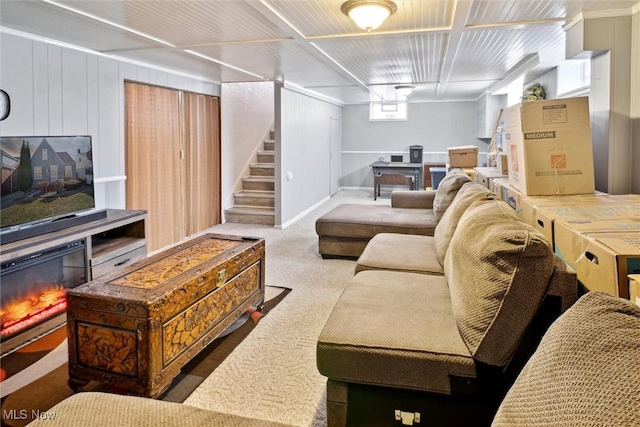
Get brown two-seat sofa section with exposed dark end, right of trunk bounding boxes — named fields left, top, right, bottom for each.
left=317, top=180, right=577, bottom=426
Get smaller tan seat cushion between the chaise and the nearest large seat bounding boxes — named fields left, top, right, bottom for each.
left=356, top=233, right=444, bottom=275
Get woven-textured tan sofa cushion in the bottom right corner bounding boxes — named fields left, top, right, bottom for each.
left=493, top=292, right=640, bottom=427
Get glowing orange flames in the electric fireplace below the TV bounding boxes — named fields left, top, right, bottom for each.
left=0, top=284, right=67, bottom=336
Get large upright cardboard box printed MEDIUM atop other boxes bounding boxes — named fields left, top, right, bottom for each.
left=503, top=97, right=595, bottom=196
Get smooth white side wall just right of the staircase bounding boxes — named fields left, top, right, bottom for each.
left=275, top=85, right=342, bottom=227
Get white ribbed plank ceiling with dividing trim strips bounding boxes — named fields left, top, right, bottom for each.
left=0, top=0, right=640, bottom=104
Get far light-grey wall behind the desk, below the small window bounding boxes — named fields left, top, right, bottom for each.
left=340, top=101, right=482, bottom=188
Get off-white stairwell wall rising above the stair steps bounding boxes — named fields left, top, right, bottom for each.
left=220, top=82, right=275, bottom=212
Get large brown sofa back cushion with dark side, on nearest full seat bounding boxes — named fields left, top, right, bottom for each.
left=444, top=200, right=554, bottom=366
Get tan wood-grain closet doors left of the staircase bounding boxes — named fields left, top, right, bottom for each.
left=125, top=82, right=221, bottom=252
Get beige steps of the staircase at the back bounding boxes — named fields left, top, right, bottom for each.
left=225, top=131, right=275, bottom=225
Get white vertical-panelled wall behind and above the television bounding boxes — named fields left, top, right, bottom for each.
left=0, top=34, right=220, bottom=208
